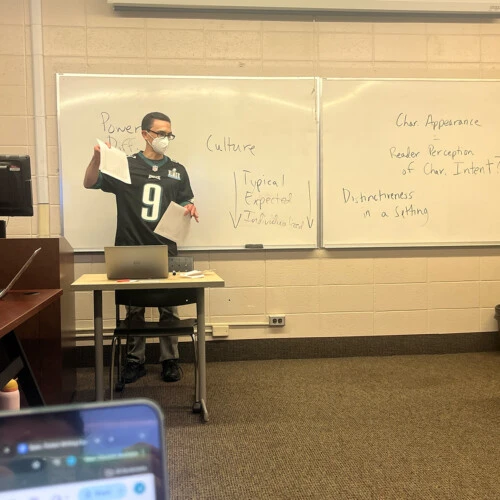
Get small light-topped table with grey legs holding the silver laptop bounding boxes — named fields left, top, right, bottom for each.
left=71, top=272, right=224, bottom=420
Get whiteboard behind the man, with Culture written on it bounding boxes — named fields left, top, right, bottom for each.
left=57, top=74, right=319, bottom=251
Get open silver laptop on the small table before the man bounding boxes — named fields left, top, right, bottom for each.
left=104, top=245, right=168, bottom=280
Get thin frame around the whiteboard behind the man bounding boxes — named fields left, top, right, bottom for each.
left=56, top=73, right=322, bottom=253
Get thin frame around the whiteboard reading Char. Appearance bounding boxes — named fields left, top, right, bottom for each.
left=318, top=77, right=500, bottom=250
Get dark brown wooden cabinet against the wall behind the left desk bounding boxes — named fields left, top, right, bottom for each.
left=0, top=238, right=76, bottom=404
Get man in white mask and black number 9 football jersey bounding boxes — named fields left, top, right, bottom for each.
left=83, top=112, right=198, bottom=384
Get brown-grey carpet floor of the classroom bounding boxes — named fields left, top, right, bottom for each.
left=76, top=352, right=500, bottom=500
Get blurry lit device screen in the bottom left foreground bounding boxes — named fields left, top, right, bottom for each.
left=0, top=400, right=169, bottom=500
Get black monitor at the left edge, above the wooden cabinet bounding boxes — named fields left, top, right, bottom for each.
left=0, top=155, right=33, bottom=217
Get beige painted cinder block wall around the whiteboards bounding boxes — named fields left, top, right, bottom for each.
left=0, top=0, right=500, bottom=339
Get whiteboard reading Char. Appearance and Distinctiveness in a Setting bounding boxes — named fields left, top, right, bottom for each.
left=321, top=79, right=500, bottom=247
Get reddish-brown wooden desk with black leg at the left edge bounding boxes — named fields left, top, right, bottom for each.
left=0, top=289, right=62, bottom=406
